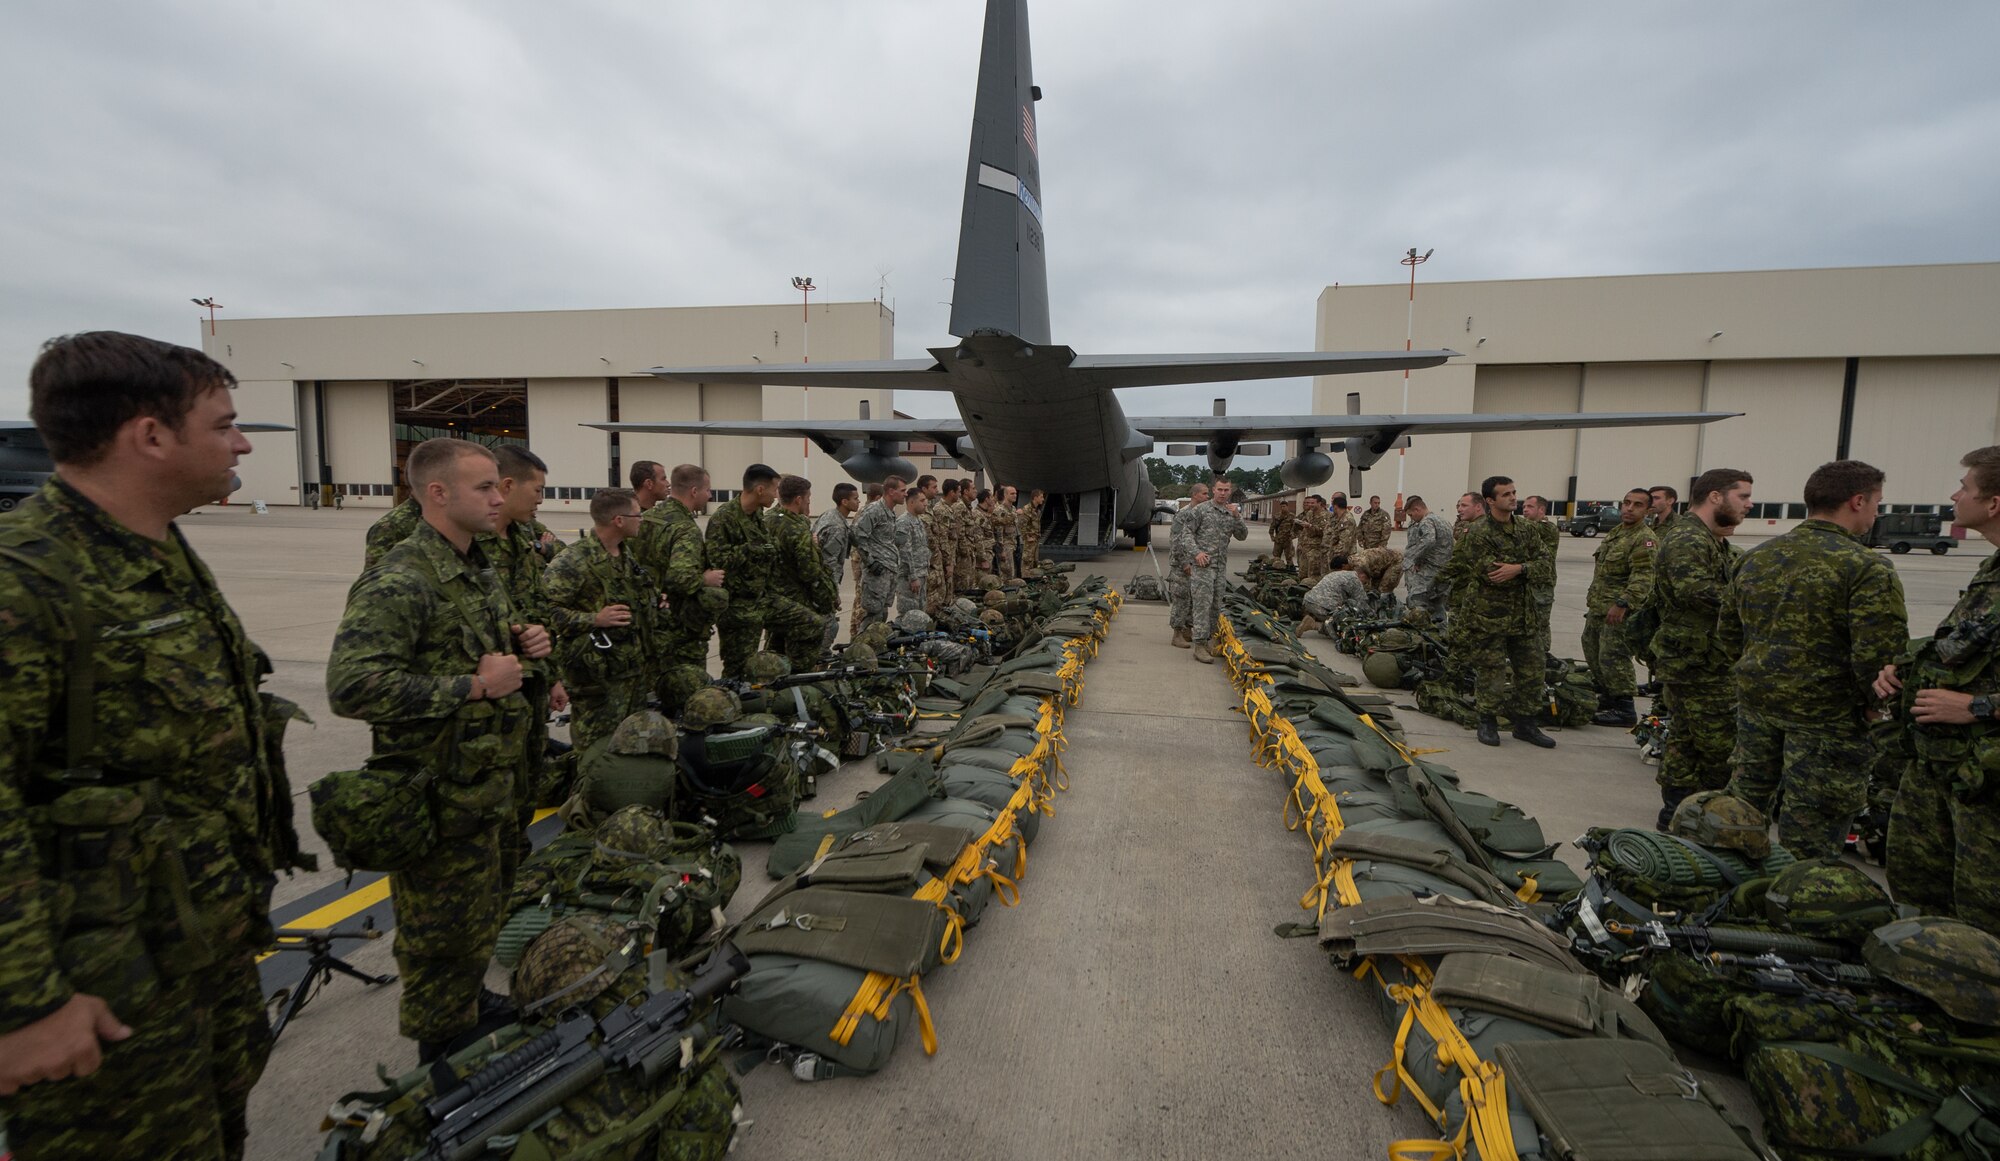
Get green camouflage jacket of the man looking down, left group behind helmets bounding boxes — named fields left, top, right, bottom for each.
left=542, top=534, right=660, bottom=693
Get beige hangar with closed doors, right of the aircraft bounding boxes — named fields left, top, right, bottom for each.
left=1312, top=262, right=2000, bottom=526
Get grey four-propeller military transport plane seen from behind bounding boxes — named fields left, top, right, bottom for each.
left=588, top=0, right=1734, bottom=558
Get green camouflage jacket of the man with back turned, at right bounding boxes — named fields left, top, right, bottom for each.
left=1716, top=520, right=1910, bottom=725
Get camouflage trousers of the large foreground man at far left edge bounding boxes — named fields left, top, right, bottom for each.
left=0, top=955, right=272, bottom=1161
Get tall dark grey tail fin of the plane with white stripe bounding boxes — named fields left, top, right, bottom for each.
left=952, top=0, right=1050, bottom=344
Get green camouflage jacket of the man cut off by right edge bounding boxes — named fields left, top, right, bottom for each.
left=1902, top=552, right=2000, bottom=764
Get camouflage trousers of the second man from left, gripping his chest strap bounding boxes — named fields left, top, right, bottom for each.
left=388, top=825, right=514, bottom=1041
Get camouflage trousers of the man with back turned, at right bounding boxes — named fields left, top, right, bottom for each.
left=1728, top=707, right=1874, bottom=859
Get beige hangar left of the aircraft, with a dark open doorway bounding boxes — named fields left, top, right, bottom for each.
left=202, top=302, right=892, bottom=522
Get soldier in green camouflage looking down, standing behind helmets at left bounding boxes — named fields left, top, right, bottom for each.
left=542, top=488, right=660, bottom=751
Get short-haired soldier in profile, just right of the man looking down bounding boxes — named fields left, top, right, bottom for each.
left=624, top=464, right=730, bottom=717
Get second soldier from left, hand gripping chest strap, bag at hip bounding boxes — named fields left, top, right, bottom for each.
left=326, top=438, right=550, bottom=1061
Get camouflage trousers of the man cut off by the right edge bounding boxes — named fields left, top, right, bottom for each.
left=1884, top=759, right=2000, bottom=931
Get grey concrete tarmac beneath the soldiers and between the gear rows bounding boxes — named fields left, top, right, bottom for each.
left=152, top=506, right=1986, bottom=1161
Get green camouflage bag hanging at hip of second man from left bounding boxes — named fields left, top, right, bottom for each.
left=306, top=757, right=438, bottom=873
